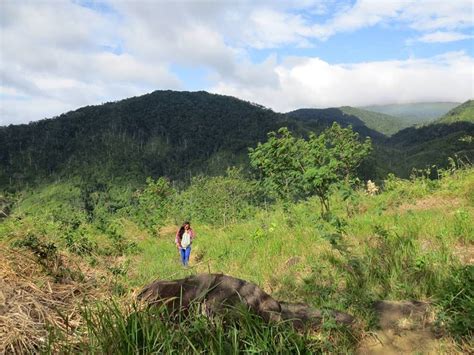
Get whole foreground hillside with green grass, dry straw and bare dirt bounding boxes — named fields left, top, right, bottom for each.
left=0, top=163, right=474, bottom=353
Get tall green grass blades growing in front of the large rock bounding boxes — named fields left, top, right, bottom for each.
left=74, top=302, right=356, bottom=354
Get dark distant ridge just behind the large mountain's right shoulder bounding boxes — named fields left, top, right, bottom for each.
left=286, top=108, right=386, bottom=141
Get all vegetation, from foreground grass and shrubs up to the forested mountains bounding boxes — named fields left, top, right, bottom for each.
left=0, top=92, right=474, bottom=353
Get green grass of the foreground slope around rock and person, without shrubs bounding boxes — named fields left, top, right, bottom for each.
left=0, top=168, right=474, bottom=353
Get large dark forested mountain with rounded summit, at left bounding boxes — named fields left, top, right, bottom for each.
left=0, top=91, right=291, bottom=185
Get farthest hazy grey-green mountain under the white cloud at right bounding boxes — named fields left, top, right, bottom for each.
left=361, top=102, right=459, bottom=127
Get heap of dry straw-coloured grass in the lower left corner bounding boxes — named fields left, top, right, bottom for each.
left=0, top=246, right=111, bottom=354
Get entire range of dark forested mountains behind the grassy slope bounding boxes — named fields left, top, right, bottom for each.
left=0, top=91, right=474, bottom=187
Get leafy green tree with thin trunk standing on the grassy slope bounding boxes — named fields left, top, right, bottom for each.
left=249, top=123, right=371, bottom=215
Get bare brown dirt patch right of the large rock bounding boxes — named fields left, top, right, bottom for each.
left=357, top=301, right=457, bottom=355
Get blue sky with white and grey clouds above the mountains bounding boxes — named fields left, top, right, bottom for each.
left=0, top=0, right=474, bottom=126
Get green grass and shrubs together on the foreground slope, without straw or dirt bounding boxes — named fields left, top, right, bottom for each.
left=0, top=142, right=474, bottom=353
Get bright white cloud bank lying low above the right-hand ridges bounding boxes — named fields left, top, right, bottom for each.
left=212, top=52, right=474, bottom=111
